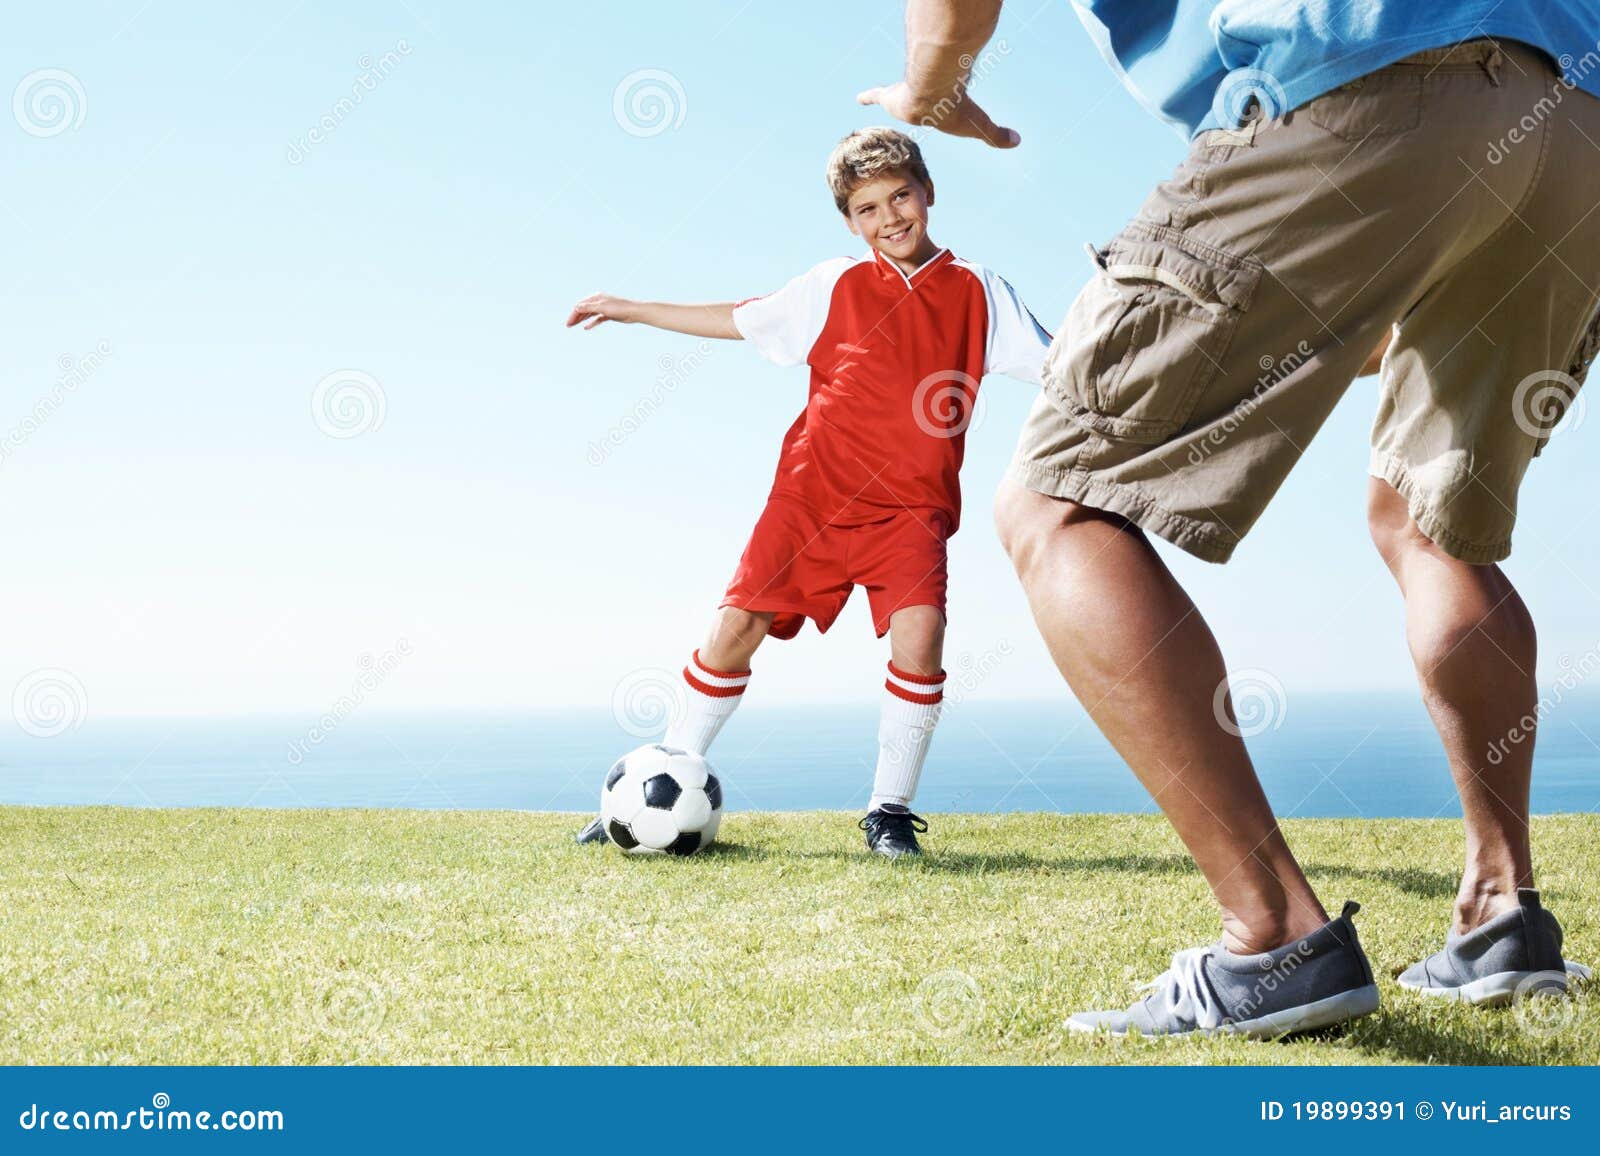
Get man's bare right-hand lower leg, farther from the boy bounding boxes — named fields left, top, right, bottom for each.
left=1368, top=479, right=1538, bottom=932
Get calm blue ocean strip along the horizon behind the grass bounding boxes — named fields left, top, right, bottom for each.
left=0, top=693, right=1600, bottom=818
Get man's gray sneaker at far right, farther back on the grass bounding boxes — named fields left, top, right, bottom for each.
left=1400, top=887, right=1589, bottom=1004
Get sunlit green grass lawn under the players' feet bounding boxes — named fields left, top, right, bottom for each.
left=0, top=807, right=1600, bottom=1063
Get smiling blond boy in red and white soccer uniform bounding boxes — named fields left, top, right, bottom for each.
left=566, top=128, right=1050, bottom=858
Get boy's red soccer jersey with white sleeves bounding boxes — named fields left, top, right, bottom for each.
left=733, top=250, right=1050, bottom=533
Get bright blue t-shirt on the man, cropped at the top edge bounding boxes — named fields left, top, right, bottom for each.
left=1072, top=0, right=1600, bottom=136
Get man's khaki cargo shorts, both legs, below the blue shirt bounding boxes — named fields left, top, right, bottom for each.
left=1011, top=40, right=1600, bottom=562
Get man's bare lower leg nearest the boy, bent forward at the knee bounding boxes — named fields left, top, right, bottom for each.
left=995, top=480, right=1328, bottom=953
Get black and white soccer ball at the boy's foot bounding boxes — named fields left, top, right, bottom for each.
left=600, top=743, right=722, bottom=855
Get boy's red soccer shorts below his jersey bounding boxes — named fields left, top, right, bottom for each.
left=722, top=498, right=950, bottom=639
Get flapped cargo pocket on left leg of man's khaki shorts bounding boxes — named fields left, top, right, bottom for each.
left=1043, top=221, right=1261, bottom=445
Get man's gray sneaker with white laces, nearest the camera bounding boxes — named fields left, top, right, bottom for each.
left=1067, top=903, right=1378, bottom=1039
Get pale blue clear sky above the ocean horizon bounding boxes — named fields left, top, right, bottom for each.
left=0, top=0, right=1600, bottom=714
